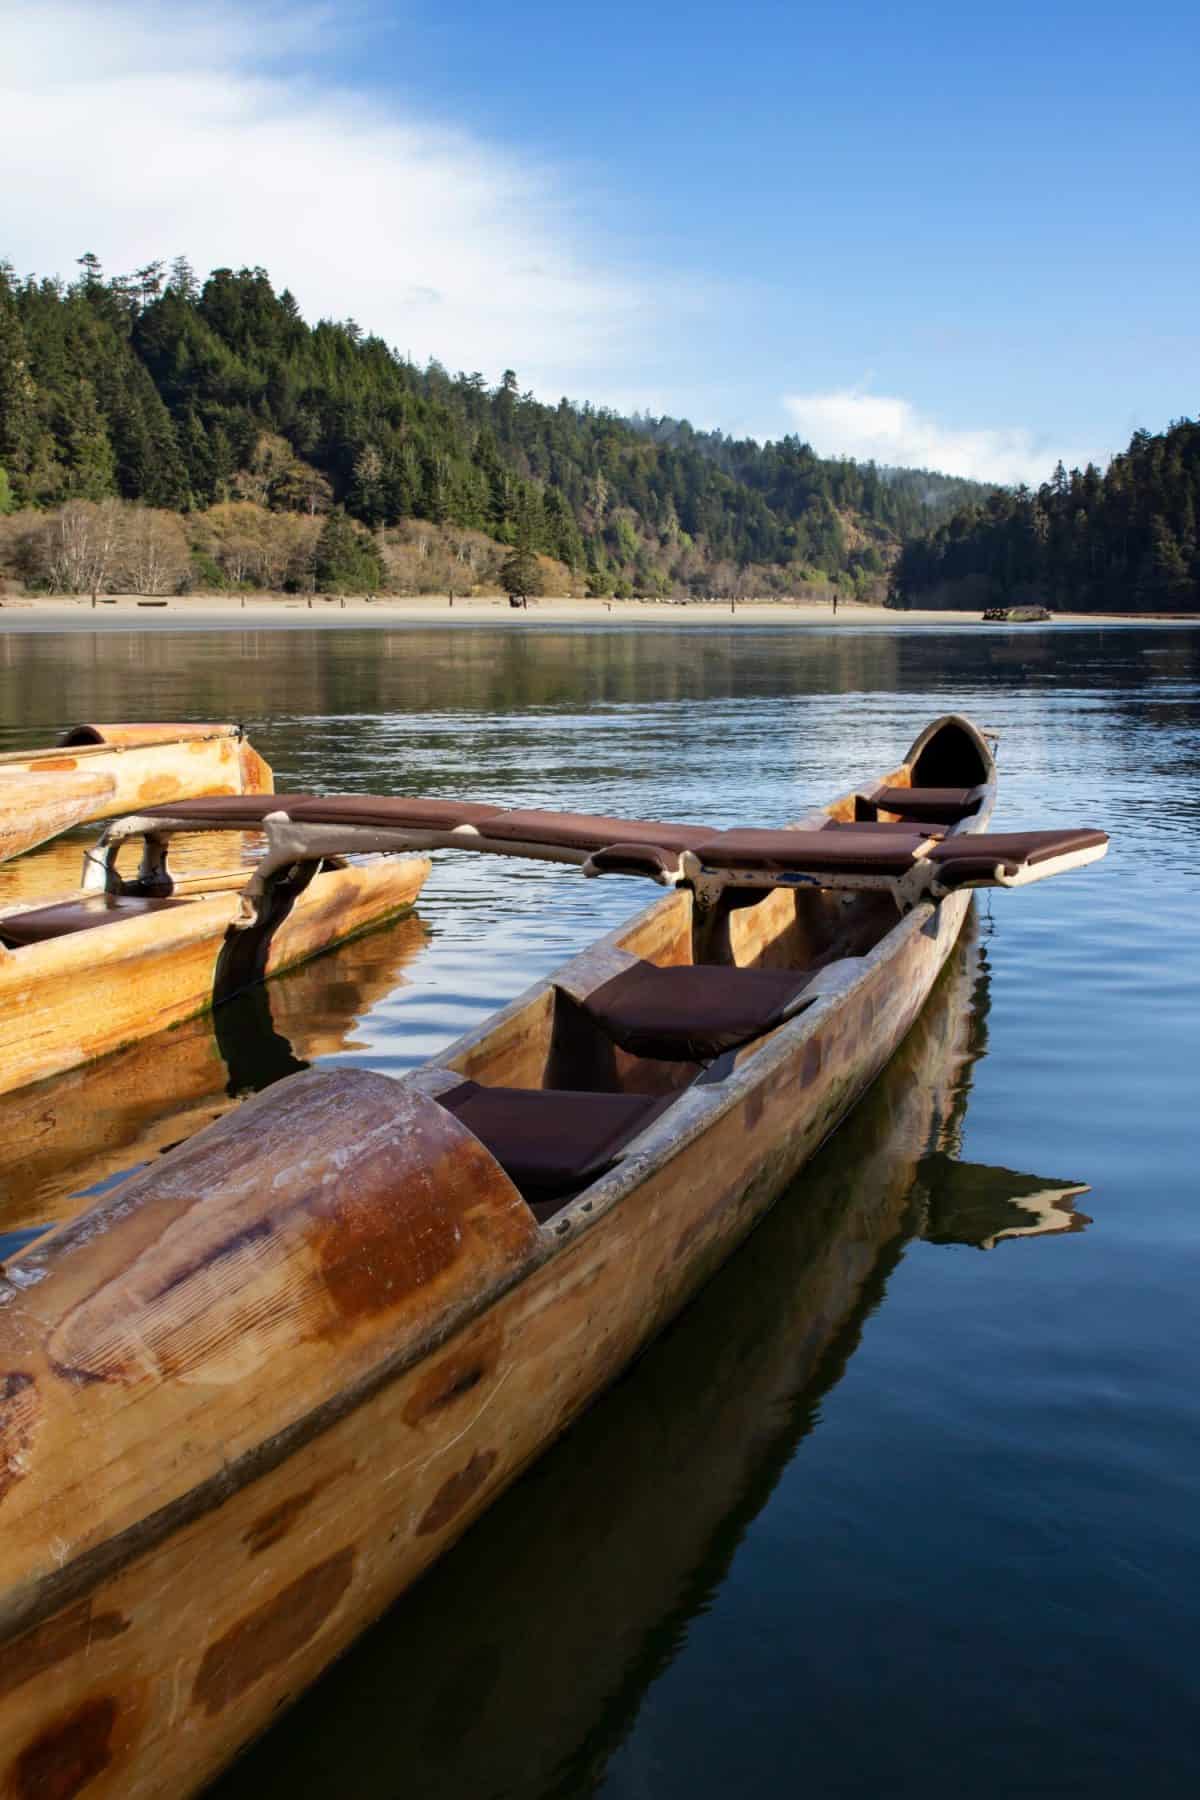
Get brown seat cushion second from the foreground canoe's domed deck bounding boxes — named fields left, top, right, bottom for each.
left=583, top=963, right=811, bottom=1062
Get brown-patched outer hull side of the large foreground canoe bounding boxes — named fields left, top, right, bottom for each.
left=0, top=895, right=968, bottom=1800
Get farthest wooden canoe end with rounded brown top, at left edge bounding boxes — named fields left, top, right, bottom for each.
left=0, top=724, right=273, bottom=860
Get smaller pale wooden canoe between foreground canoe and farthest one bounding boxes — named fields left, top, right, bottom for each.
left=0, top=833, right=430, bottom=1094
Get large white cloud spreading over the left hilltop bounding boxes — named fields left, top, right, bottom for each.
left=0, top=0, right=651, bottom=394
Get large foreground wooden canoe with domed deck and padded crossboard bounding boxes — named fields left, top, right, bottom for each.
left=0, top=720, right=1106, bottom=1800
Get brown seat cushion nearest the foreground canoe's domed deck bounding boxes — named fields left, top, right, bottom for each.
left=437, top=1082, right=671, bottom=1201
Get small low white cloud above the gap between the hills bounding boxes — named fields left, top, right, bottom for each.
left=783, top=389, right=1106, bottom=488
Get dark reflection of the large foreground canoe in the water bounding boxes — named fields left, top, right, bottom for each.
left=212, top=918, right=1090, bottom=1800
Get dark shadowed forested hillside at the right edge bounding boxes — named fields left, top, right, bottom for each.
left=894, top=419, right=1200, bottom=612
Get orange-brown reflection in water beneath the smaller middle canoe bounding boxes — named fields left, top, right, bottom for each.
left=0, top=914, right=428, bottom=1255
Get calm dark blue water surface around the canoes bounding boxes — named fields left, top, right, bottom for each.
left=0, top=626, right=1200, bottom=1800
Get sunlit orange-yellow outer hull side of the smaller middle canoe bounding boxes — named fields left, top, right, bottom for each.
left=0, top=857, right=430, bottom=1094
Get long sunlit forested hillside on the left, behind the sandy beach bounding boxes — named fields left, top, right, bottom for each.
left=0, top=256, right=990, bottom=594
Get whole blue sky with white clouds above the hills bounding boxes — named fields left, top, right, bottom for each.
left=0, top=0, right=1200, bottom=481
